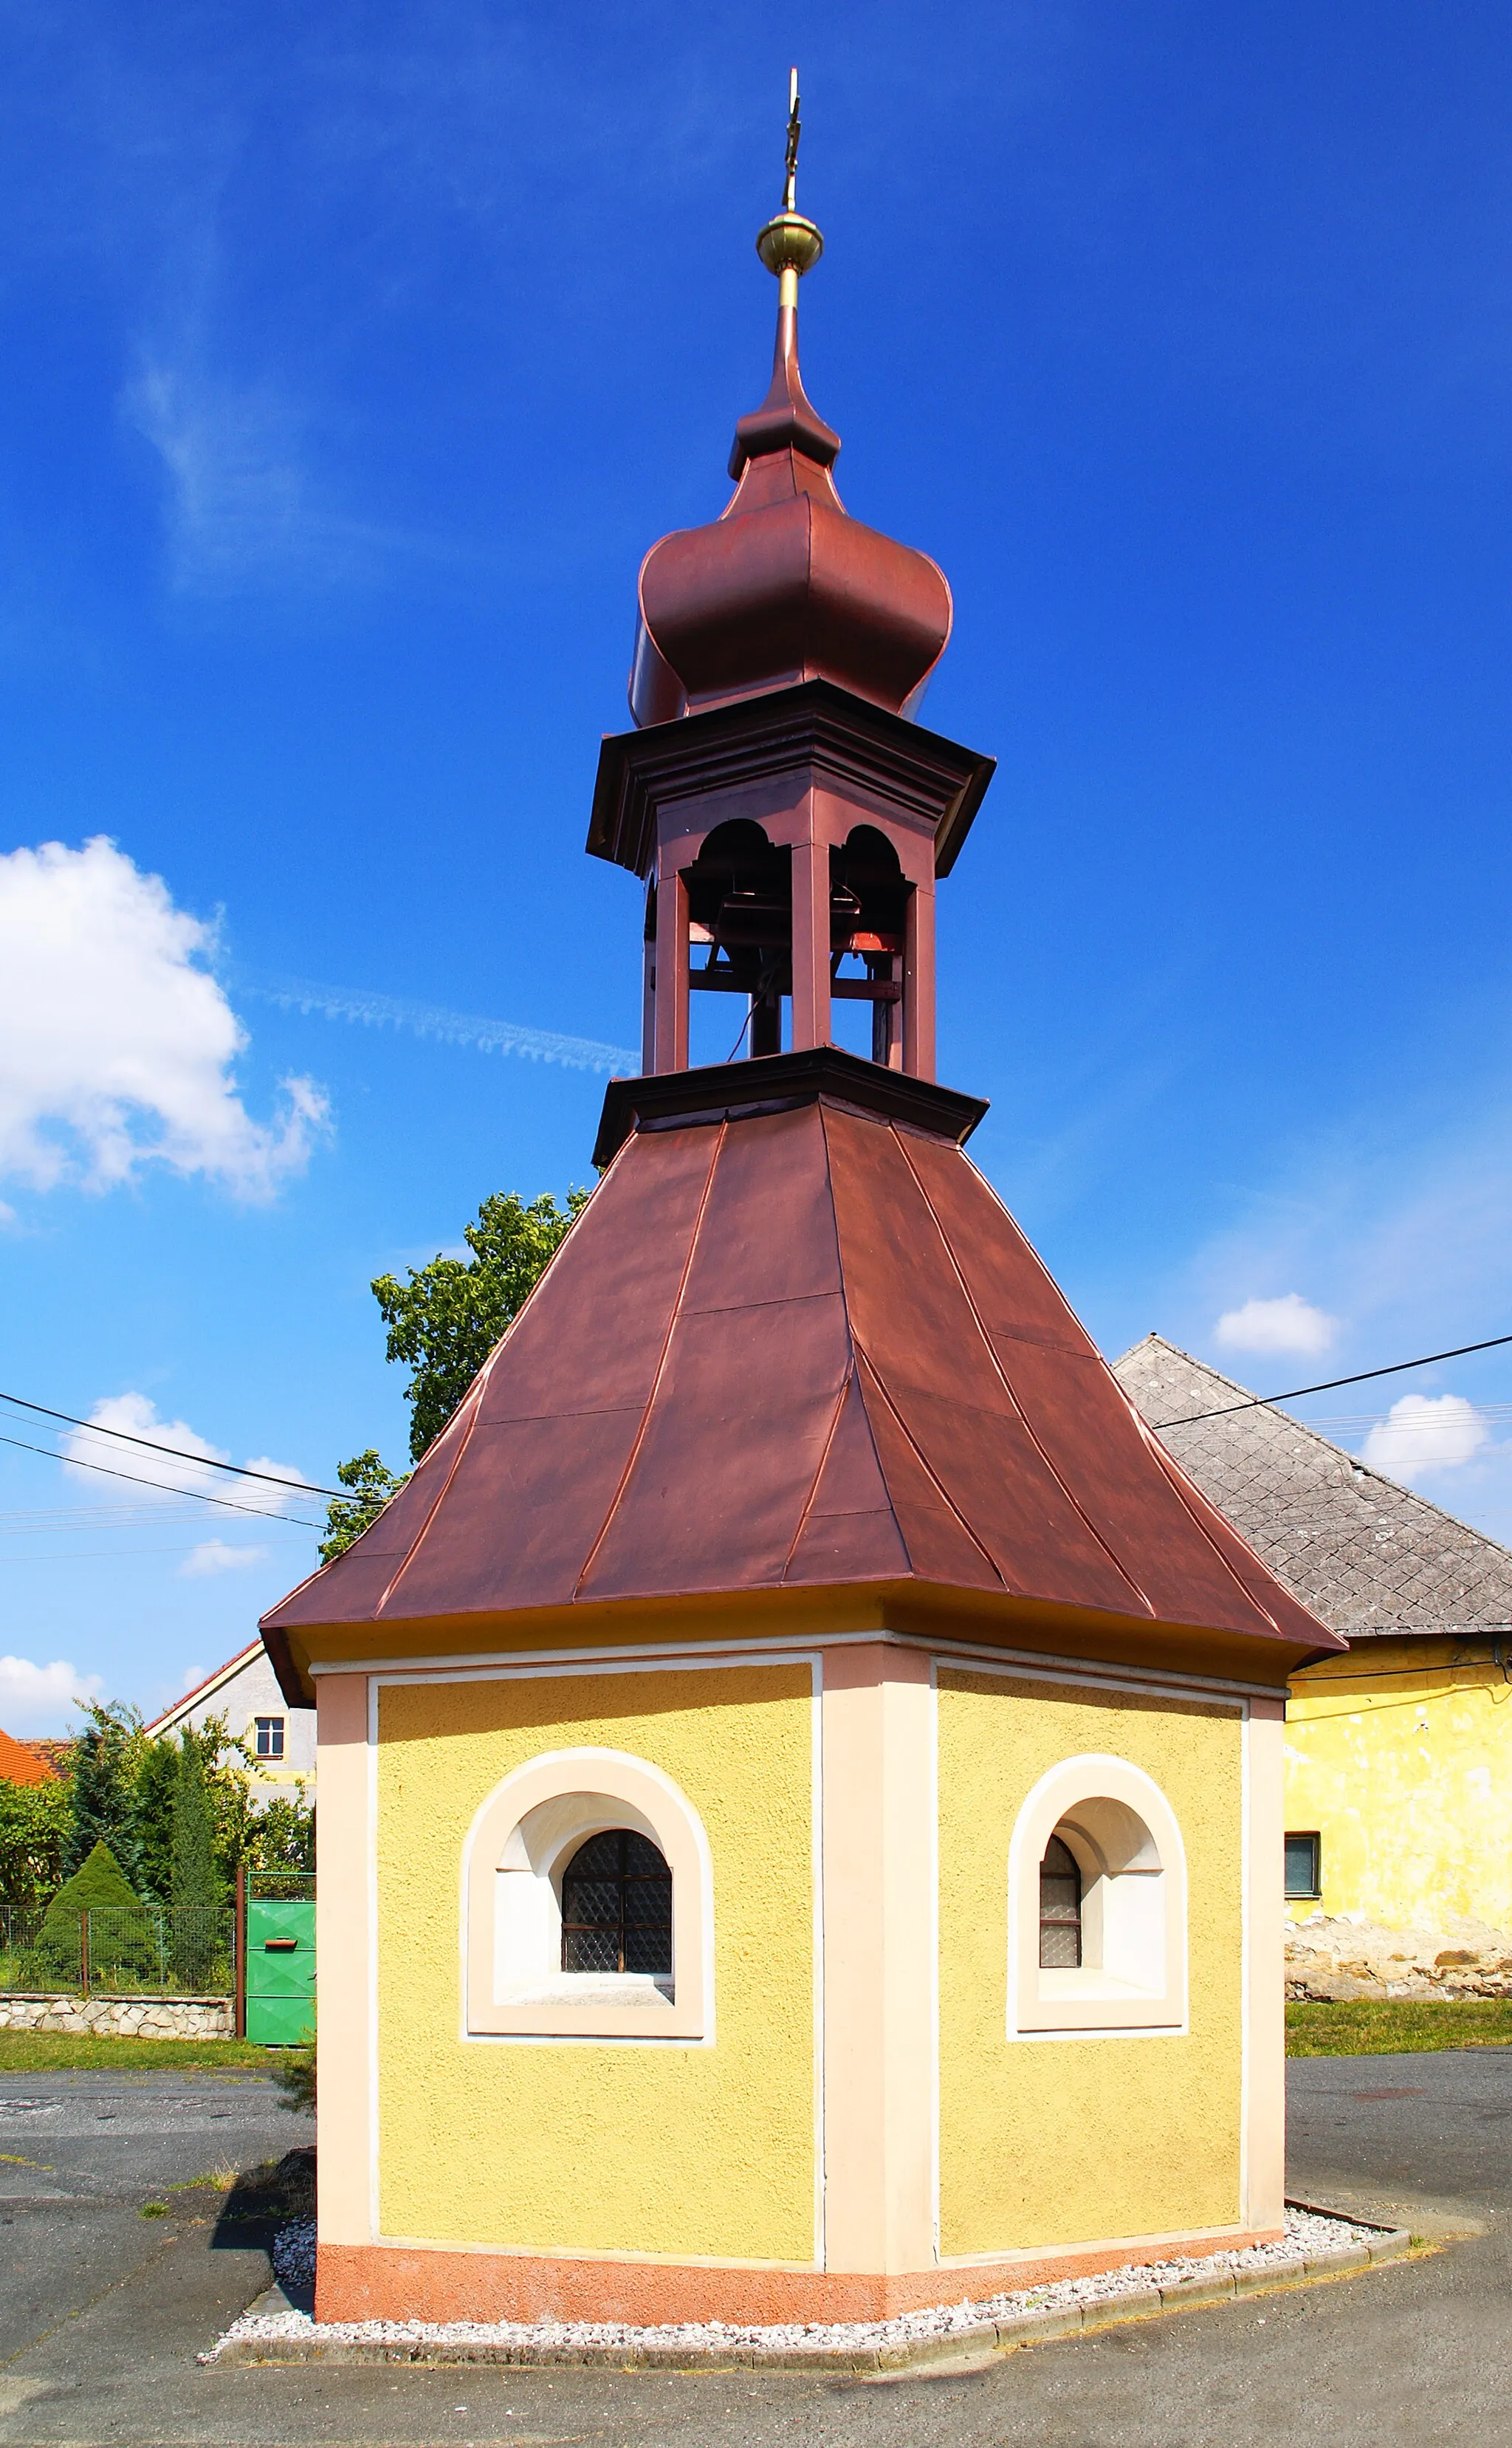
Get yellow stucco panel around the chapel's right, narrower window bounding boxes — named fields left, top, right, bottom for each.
left=940, top=1670, right=1243, bottom=2255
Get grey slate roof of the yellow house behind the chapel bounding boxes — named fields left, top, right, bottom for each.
left=1113, top=1334, right=1512, bottom=1640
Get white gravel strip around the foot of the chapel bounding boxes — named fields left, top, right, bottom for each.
left=198, top=2204, right=1409, bottom=2370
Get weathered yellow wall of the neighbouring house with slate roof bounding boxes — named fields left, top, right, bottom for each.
left=1287, top=1640, right=1512, bottom=1929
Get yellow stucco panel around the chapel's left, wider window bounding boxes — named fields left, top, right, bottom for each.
left=377, top=1664, right=815, bottom=2262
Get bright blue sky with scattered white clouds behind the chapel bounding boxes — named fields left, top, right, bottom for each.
left=0, top=0, right=1512, bottom=1731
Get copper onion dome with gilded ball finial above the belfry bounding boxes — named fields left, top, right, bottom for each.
left=629, top=142, right=952, bottom=727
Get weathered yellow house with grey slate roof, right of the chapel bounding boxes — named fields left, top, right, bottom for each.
left=1113, top=1334, right=1512, bottom=1998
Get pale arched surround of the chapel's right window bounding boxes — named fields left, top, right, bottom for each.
left=1008, top=1750, right=1186, bottom=2039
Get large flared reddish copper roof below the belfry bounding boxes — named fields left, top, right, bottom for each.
left=264, top=1055, right=1336, bottom=1689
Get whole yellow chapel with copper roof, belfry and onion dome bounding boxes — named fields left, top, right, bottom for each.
left=262, top=81, right=1343, bottom=2325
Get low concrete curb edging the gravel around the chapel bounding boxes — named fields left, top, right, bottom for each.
left=208, top=2204, right=1412, bottom=2372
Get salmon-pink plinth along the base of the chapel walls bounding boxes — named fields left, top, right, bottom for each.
left=315, top=2228, right=1282, bottom=2328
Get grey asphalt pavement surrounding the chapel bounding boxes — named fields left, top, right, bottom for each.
left=0, top=2049, right=1512, bottom=2448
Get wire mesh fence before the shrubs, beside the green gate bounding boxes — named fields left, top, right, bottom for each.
left=0, top=1902, right=235, bottom=1998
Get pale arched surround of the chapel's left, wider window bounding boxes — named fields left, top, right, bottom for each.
left=462, top=1746, right=715, bottom=2044
